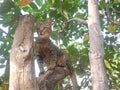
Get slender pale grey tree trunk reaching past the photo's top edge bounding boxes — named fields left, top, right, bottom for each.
left=88, top=0, right=109, bottom=90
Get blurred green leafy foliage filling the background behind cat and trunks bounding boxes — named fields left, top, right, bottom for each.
left=0, top=0, right=120, bottom=90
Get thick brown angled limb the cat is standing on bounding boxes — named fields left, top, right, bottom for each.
left=38, top=67, right=69, bottom=90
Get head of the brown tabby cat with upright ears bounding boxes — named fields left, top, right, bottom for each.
left=37, top=19, right=52, bottom=40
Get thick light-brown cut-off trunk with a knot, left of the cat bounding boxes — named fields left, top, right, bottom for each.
left=9, top=15, right=36, bottom=90
